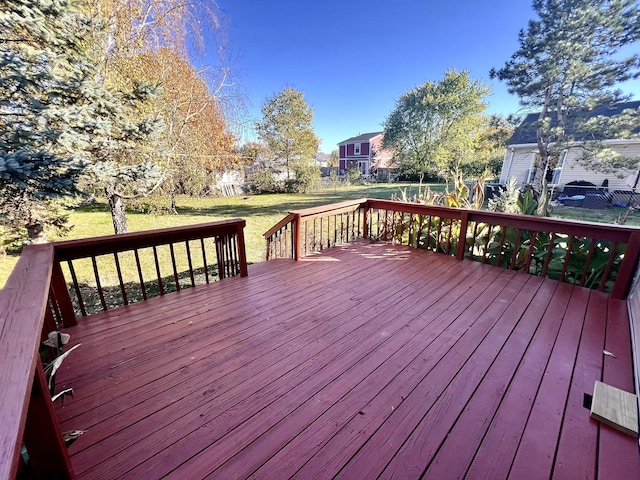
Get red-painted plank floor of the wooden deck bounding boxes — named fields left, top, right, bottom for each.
left=57, top=243, right=640, bottom=480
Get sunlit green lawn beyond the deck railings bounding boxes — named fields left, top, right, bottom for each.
left=0, top=184, right=640, bottom=288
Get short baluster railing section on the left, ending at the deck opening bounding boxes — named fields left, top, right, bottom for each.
left=55, top=219, right=247, bottom=316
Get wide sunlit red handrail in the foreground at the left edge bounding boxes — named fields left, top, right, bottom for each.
left=0, top=244, right=54, bottom=480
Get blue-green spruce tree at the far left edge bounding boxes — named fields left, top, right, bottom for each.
left=0, top=0, right=90, bottom=242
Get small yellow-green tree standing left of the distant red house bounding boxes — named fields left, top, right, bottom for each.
left=256, top=87, right=319, bottom=179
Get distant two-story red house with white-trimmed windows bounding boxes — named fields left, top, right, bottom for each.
left=338, top=132, right=393, bottom=175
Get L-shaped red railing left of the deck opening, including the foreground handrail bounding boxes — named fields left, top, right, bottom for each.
left=0, top=219, right=247, bottom=480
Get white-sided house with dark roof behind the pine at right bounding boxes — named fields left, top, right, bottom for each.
left=500, top=101, right=640, bottom=192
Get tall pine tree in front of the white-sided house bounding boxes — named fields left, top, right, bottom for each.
left=491, top=0, right=640, bottom=192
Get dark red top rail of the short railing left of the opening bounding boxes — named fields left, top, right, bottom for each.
left=53, top=218, right=246, bottom=260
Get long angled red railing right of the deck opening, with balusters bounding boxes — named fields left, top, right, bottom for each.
left=265, top=199, right=640, bottom=298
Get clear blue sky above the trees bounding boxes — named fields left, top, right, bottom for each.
left=218, top=0, right=636, bottom=153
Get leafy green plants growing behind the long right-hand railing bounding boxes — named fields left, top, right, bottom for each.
left=373, top=176, right=626, bottom=292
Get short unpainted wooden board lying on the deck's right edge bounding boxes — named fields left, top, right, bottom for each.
left=591, top=381, right=638, bottom=437
